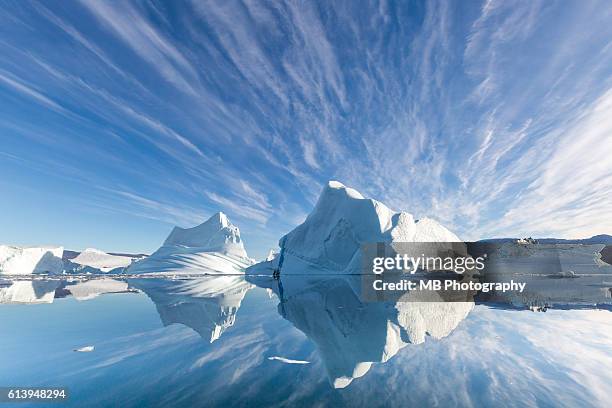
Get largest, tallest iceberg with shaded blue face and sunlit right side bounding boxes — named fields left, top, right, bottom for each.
left=247, top=181, right=461, bottom=274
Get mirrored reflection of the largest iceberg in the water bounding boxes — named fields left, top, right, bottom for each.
left=246, top=275, right=474, bottom=388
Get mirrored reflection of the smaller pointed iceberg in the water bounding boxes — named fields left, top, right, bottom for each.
left=128, top=276, right=253, bottom=343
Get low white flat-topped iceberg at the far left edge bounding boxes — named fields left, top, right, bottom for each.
left=0, top=245, right=64, bottom=275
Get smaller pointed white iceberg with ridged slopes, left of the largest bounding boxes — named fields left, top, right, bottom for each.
left=127, top=212, right=253, bottom=275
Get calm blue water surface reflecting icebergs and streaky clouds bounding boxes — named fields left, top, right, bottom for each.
left=0, top=276, right=612, bottom=407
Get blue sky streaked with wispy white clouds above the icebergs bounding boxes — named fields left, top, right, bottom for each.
left=0, top=1, right=612, bottom=257
